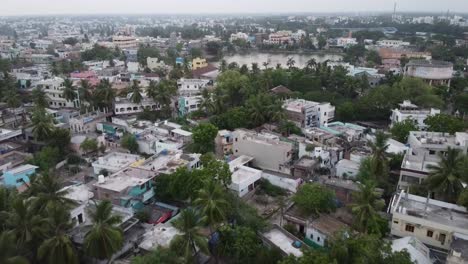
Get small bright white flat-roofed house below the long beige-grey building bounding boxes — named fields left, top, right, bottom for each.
left=229, top=155, right=262, bottom=197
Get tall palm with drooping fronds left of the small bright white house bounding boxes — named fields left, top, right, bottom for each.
left=193, top=180, right=229, bottom=233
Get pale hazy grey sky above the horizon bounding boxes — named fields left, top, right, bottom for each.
left=0, top=0, right=468, bottom=15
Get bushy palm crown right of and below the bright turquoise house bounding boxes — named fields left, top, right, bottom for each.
left=27, top=173, right=75, bottom=212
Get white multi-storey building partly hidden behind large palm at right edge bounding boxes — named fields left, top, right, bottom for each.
left=398, top=131, right=468, bottom=189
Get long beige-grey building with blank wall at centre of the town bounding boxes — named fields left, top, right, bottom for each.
left=232, top=129, right=293, bottom=173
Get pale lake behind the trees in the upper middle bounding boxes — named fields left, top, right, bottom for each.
left=219, top=52, right=343, bottom=68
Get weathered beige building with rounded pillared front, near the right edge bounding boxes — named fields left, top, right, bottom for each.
left=404, top=60, right=453, bottom=86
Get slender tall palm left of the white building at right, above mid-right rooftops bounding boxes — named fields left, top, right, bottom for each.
left=369, top=131, right=389, bottom=182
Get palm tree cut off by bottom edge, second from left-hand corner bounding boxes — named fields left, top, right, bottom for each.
left=37, top=205, right=79, bottom=264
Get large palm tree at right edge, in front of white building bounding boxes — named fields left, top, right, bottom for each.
left=426, top=148, right=466, bottom=203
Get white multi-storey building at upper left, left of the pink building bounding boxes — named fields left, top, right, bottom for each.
left=36, top=77, right=80, bottom=108
